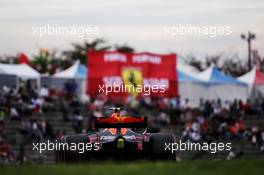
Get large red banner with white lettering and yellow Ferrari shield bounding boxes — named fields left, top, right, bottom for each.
left=87, top=51, right=178, bottom=97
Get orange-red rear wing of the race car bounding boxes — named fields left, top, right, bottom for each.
left=95, top=116, right=147, bottom=128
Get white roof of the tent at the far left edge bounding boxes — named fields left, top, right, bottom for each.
left=0, top=64, right=40, bottom=79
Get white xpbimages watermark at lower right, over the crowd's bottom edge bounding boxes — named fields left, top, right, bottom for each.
left=164, top=140, right=232, bottom=154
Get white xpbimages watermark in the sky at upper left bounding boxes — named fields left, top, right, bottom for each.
left=32, top=24, right=100, bottom=38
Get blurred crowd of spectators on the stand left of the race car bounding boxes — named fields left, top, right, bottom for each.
left=0, top=80, right=79, bottom=162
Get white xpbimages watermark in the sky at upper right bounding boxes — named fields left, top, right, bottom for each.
left=164, top=24, right=232, bottom=38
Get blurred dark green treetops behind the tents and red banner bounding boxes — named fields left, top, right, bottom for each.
left=0, top=38, right=264, bottom=77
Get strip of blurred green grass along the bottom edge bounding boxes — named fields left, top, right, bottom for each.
left=0, top=159, right=264, bottom=175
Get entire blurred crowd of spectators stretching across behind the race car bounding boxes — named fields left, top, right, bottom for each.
left=0, top=81, right=264, bottom=162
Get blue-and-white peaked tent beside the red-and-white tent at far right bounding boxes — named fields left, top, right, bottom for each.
left=196, top=66, right=248, bottom=101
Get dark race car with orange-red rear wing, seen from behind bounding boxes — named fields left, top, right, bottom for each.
left=57, top=107, right=176, bottom=162
